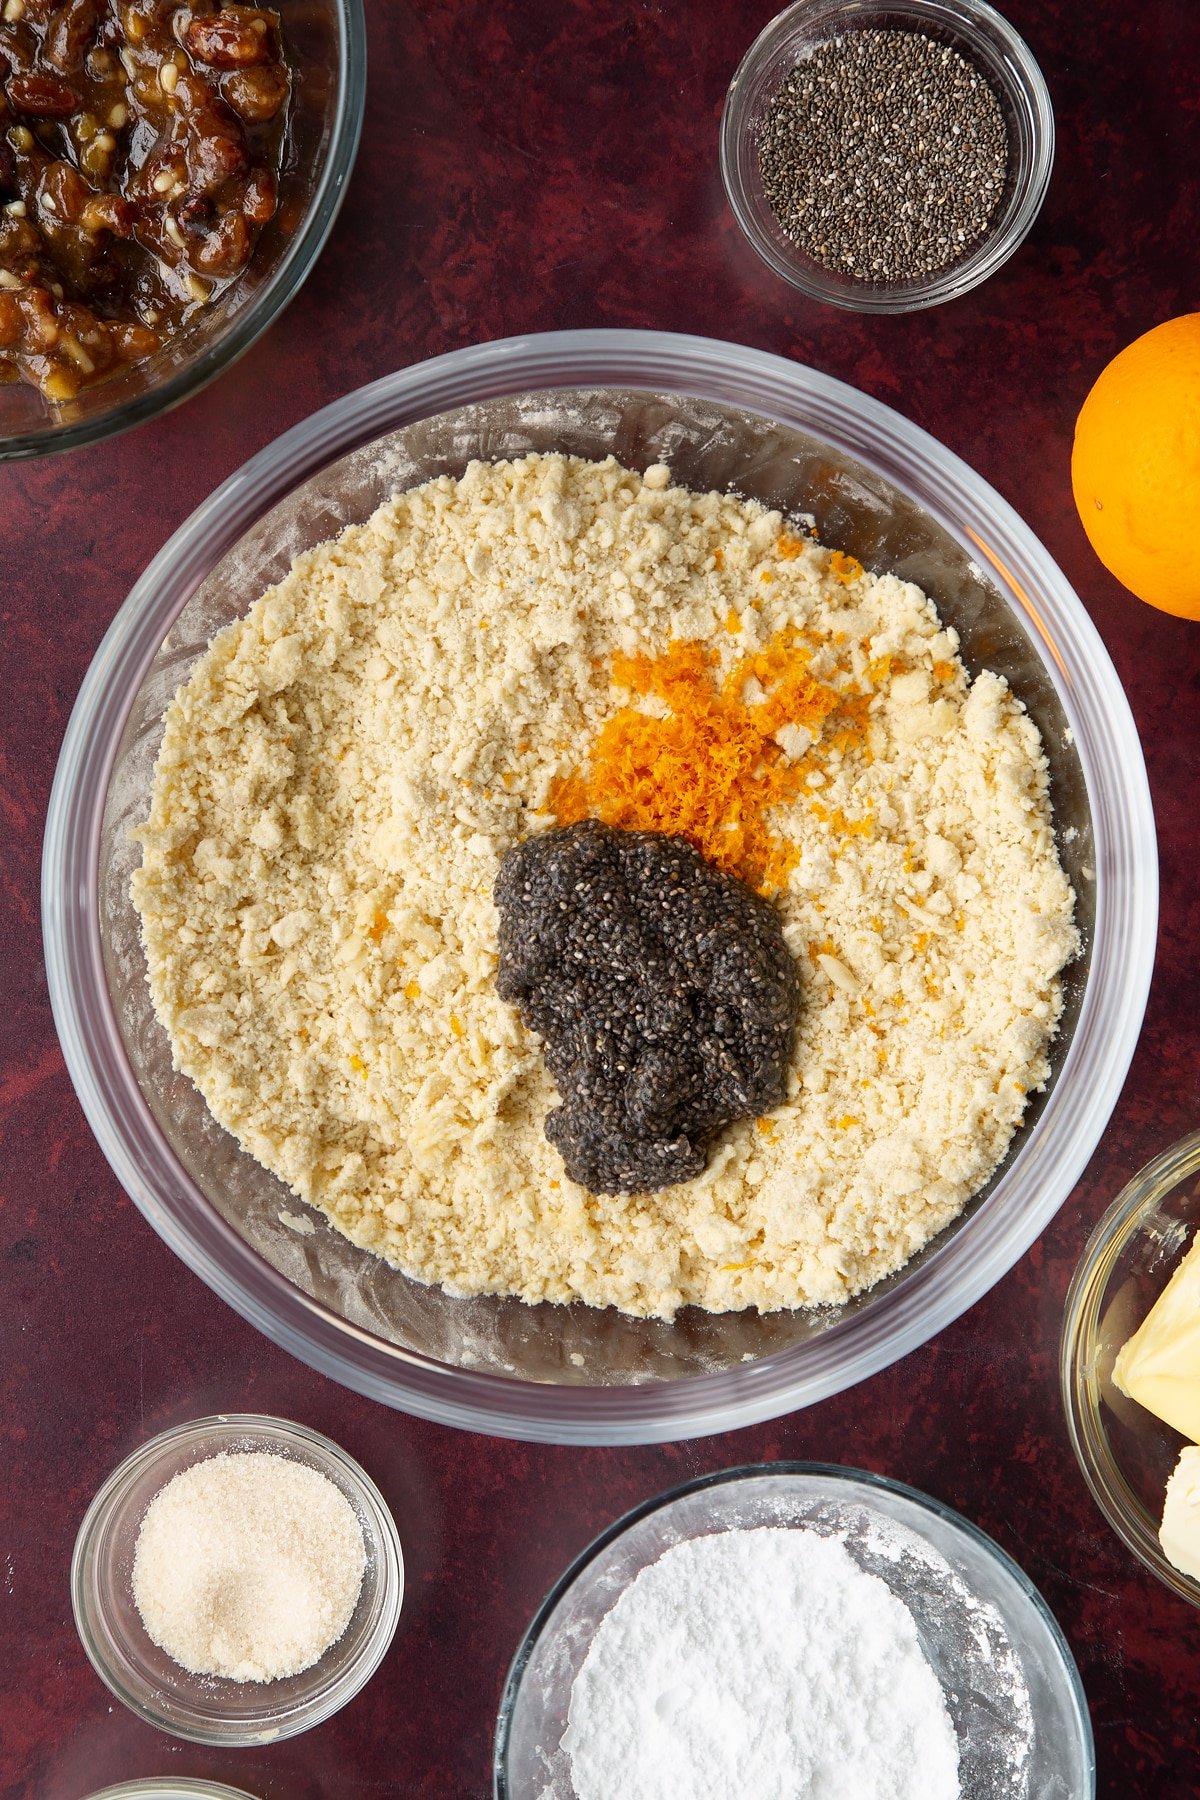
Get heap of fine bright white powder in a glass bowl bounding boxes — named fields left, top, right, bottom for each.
left=563, top=1526, right=961, bottom=1800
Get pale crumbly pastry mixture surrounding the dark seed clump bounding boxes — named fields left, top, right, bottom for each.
left=133, top=455, right=1078, bottom=1318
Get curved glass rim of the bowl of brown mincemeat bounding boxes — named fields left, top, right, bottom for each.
left=0, top=0, right=367, bottom=463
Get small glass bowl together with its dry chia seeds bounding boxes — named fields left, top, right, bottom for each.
left=721, top=0, right=1054, bottom=313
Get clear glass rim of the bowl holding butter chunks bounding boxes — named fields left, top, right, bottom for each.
left=1058, top=1130, right=1200, bottom=1607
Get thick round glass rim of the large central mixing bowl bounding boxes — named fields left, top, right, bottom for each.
left=41, top=329, right=1159, bottom=1444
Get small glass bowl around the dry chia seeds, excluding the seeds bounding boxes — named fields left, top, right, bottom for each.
left=720, top=0, right=1054, bottom=313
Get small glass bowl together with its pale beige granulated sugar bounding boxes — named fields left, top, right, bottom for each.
left=70, top=1413, right=405, bottom=1746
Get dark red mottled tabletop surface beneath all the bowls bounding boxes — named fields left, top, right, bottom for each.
left=0, top=0, right=1200, bottom=1800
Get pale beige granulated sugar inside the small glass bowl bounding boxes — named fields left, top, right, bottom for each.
left=133, top=1451, right=367, bottom=1681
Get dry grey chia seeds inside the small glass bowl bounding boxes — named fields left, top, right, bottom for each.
left=757, top=31, right=1007, bottom=281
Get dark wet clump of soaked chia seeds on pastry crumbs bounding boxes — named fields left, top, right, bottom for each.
left=495, top=819, right=799, bottom=1193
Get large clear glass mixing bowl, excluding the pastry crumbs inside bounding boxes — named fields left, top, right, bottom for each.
left=43, top=331, right=1157, bottom=1444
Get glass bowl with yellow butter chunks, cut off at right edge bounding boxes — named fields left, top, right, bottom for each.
left=1061, top=1130, right=1200, bottom=1606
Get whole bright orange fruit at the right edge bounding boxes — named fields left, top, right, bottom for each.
left=1070, top=313, right=1200, bottom=619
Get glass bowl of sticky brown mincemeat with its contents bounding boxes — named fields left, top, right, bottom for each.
left=0, top=0, right=367, bottom=461
